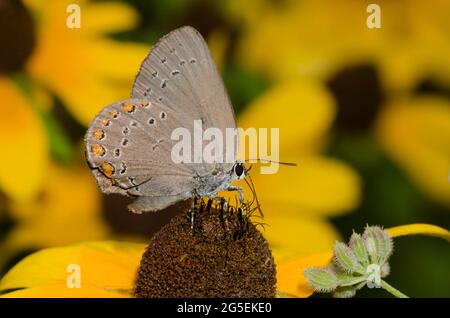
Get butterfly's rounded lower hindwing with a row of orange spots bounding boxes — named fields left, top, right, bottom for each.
left=85, top=99, right=194, bottom=212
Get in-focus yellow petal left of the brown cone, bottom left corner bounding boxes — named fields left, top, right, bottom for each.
left=0, top=241, right=145, bottom=297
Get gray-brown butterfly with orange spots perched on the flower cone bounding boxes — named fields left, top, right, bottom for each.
left=85, top=26, right=247, bottom=213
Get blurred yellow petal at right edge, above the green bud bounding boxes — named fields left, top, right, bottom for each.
left=376, top=95, right=450, bottom=206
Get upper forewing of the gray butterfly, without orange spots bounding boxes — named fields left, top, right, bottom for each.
left=132, top=26, right=238, bottom=175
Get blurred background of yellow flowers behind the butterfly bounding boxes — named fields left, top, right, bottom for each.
left=0, top=0, right=450, bottom=297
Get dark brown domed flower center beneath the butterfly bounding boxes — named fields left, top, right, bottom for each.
left=134, top=204, right=276, bottom=298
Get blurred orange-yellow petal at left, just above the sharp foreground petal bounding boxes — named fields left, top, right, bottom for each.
left=2, top=164, right=109, bottom=256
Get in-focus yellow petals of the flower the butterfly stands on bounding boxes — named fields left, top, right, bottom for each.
left=0, top=224, right=450, bottom=297
